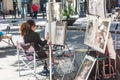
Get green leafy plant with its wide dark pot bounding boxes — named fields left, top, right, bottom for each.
left=62, top=4, right=76, bottom=26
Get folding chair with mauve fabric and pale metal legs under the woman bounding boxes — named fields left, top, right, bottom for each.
left=17, top=43, right=36, bottom=77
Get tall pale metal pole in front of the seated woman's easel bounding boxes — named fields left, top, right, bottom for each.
left=48, top=0, right=52, bottom=80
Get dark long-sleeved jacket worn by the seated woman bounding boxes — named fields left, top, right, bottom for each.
left=24, top=31, right=47, bottom=50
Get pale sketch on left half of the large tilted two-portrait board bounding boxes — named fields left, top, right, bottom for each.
left=84, top=16, right=97, bottom=47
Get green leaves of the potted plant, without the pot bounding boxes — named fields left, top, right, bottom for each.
left=62, top=5, right=74, bottom=19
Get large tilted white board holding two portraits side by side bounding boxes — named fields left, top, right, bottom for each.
left=84, top=17, right=111, bottom=53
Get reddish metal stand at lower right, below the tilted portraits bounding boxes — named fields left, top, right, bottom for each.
left=95, top=52, right=116, bottom=80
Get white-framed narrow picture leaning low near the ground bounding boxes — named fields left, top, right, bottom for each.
left=75, top=55, right=96, bottom=80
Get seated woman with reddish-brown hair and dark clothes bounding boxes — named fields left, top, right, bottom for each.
left=20, top=20, right=49, bottom=74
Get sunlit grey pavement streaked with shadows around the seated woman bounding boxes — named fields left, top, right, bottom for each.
left=0, top=16, right=120, bottom=80
